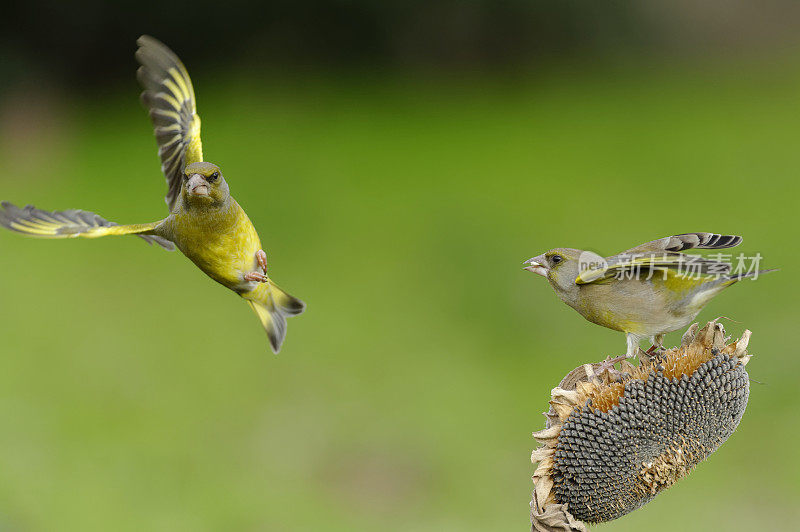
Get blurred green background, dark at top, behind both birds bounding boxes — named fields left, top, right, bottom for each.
left=0, top=1, right=800, bottom=531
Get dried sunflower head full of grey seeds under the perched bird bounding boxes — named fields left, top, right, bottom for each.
left=531, top=320, right=750, bottom=532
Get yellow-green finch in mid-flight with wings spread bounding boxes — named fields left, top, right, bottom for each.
left=0, top=36, right=305, bottom=353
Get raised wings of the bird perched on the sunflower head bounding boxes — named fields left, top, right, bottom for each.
left=575, top=233, right=742, bottom=285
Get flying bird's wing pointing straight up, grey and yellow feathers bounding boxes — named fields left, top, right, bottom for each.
left=136, top=35, right=203, bottom=211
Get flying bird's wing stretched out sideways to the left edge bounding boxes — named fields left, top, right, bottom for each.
left=0, top=201, right=175, bottom=251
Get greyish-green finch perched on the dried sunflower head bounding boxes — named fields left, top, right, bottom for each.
left=524, top=233, right=772, bottom=358
